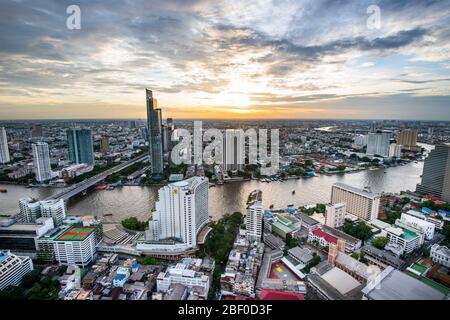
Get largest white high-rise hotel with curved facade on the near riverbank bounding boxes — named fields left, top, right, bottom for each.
left=147, top=177, right=209, bottom=248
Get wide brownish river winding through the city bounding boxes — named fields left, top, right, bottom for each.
left=0, top=162, right=423, bottom=221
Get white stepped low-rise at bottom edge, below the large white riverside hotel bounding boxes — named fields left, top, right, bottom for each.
left=156, top=263, right=209, bottom=299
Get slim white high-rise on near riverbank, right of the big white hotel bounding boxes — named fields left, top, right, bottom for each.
left=245, top=190, right=263, bottom=242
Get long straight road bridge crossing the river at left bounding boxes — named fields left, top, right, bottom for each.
left=45, top=154, right=148, bottom=201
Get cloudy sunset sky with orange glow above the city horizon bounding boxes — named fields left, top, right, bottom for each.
left=0, top=0, right=450, bottom=120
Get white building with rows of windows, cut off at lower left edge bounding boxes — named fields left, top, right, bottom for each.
left=0, top=251, right=33, bottom=290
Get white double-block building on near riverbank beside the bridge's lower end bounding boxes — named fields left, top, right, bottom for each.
left=19, top=198, right=66, bottom=226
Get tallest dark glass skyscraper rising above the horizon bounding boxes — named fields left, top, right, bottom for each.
left=145, top=89, right=164, bottom=175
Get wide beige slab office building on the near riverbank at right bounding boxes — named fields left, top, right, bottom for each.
left=331, top=182, right=380, bottom=221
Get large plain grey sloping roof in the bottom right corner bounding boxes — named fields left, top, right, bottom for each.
left=362, top=266, right=446, bottom=300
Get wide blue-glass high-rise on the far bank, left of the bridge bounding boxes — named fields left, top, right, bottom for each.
left=66, top=128, right=95, bottom=164
